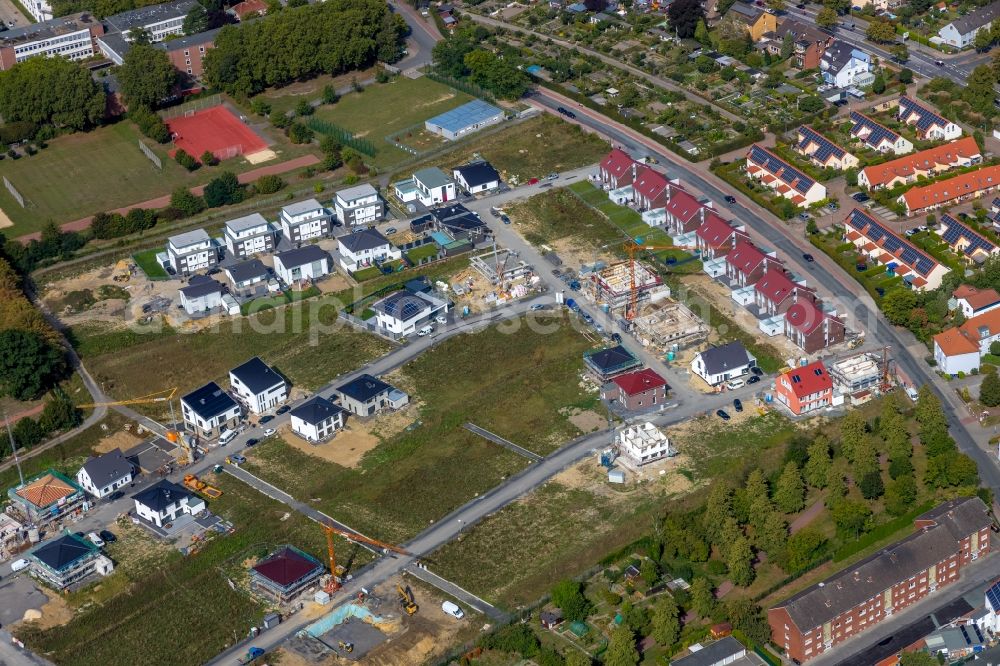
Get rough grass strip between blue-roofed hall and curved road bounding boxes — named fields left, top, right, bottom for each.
left=392, top=115, right=608, bottom=182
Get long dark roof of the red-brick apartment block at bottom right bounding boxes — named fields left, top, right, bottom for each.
left=776, top=497, right=992, bottom=632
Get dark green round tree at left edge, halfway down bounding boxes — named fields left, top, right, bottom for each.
left=0, top=330, right=66, bottom=400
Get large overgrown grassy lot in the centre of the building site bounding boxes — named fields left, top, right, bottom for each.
left=247, top=326, right=594, bottom=542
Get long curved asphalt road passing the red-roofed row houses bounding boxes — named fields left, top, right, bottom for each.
left=532, top=89, right=1000, bottom=489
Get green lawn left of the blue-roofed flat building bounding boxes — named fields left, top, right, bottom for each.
left=304, top=76, right=472, bottom=169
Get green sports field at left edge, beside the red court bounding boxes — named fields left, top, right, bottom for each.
left=0, top=121, right=309, bottom=237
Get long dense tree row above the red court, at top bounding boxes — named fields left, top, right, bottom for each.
left=205, top=0, right=407, bottom=97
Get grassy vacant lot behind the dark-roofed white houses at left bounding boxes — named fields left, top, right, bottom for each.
left=73, top=303, right=391, bottom=408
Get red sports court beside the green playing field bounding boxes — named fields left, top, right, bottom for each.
left=164, top=105, right=267, bottom=160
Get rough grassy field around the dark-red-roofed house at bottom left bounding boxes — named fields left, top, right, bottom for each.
left=17, top=476, right=369, bottom=666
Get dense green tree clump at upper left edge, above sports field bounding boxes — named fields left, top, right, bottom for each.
left=0, top=58, right=105, bottom=130
